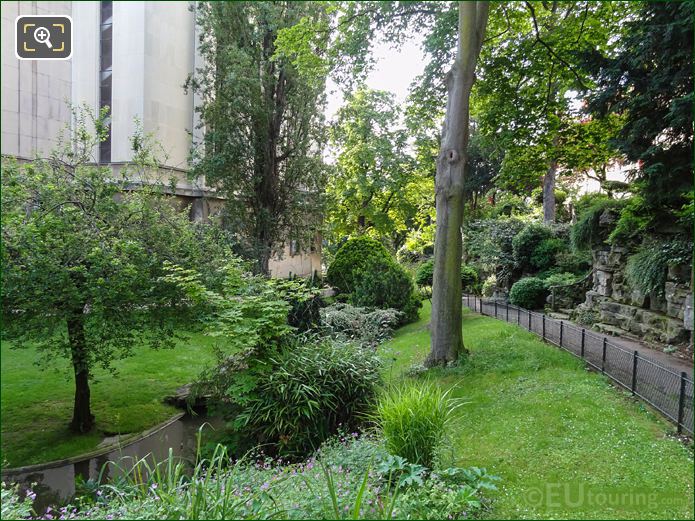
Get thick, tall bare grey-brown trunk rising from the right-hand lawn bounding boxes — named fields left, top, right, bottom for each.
left=425, top=2, right=488, bottom=367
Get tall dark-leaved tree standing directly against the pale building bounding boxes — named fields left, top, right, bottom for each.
left=186, top=2, right=327, bottom=274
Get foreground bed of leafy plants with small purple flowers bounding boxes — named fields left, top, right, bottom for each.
left=13, top=433, right=499, bottom=520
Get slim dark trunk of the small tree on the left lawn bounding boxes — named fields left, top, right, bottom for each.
left=68, top=309, right=94, bottom=433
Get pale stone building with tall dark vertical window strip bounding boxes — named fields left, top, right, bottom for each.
left=0, top=1, right=321, bottom=277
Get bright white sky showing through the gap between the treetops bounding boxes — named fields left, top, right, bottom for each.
left=326, top=35, right=425, bottom=121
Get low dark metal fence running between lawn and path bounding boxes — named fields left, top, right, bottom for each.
left=463, top=295, right=693, bottom=434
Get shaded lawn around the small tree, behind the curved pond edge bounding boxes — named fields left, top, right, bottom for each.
left=0, top=334, right=215, bottom=467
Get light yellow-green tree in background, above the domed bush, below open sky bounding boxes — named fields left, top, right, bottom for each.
left=327, top=88, right=420, bottom=248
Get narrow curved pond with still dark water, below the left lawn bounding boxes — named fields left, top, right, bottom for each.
left=2, top=413, right=224, bottom=514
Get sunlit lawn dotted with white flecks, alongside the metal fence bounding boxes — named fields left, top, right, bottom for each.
left=383, top=304, right=694, bottom=519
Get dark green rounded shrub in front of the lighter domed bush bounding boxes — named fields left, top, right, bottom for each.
left=351, top=259, right=422, bottom=324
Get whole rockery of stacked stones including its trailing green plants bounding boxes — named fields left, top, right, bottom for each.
left=571, top=208, right=693, bottom=350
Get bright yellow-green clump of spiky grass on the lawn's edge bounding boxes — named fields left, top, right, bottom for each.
left=375, top=382, right=456, bottom=468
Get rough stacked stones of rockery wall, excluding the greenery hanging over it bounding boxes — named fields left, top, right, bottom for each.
left=580, top=246, right=693, bottom=344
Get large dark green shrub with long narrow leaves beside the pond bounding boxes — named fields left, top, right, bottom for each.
left=215, top=338, right=381, bottom=457
